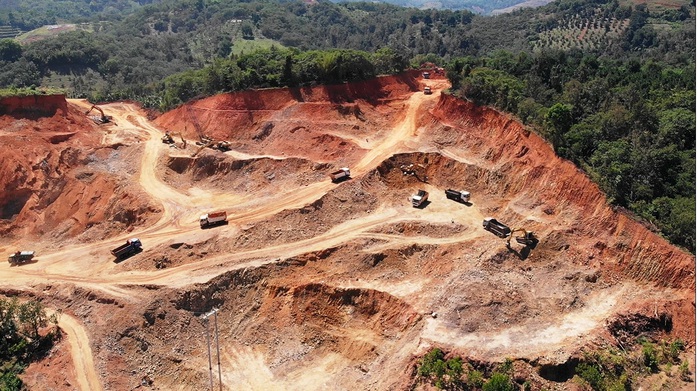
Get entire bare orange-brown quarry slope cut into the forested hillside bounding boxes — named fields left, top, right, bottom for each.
left=0, top=73, right=695, bottom=390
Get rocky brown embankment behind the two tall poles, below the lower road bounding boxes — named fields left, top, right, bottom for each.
left=95, top=258, right=421, bottom=389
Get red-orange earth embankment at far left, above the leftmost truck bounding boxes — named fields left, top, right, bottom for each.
left=0, top=96, right=157, bottom=247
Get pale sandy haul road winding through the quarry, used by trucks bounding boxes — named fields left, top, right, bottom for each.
left=3, top=80, right=446, bottom=391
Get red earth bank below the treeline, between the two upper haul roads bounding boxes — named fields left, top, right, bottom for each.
left=155, top=73, right=419, bottom=149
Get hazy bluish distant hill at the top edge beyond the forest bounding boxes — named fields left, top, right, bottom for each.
left=333, top=0, right=554, bottom=15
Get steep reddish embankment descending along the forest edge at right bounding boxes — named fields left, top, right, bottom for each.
left=424, top=95, right=696, bottom=288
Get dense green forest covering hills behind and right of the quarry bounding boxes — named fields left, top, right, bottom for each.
left=0, top=0, right=696, bottom=252
